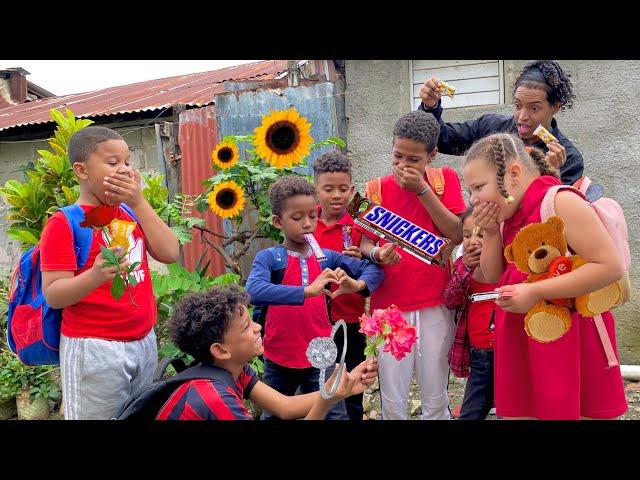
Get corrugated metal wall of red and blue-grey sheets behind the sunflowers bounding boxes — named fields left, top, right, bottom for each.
left=178, top=76, right=346, bottom=278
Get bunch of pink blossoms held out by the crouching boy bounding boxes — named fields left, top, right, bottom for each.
left=360, top=305, right=416, bottom=360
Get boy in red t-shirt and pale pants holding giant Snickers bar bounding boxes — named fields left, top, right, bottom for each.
left=360, top=111, right=465, bottom=420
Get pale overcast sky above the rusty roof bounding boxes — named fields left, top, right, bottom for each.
left=0, top=60, right=257, bottom=95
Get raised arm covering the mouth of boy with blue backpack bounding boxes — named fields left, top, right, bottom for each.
left=105, top=171, right=180, bottom=263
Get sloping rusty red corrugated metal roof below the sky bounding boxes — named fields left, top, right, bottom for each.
left=0, top=60, right=287, bottom=131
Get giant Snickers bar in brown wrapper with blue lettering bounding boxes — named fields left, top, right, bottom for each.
left=347, top=193, right=453, bottom=265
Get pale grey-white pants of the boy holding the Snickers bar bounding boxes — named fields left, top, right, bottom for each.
left=378, top=305, right=454, bottom=420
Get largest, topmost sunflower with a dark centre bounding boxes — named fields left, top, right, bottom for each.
left=253, top=108, right=313, bottom=168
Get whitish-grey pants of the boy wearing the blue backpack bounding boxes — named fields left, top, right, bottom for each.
left=60, top=328, right=158, bottom=420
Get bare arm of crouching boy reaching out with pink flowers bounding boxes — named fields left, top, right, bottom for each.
left=249, top=358, right=378, bottom=420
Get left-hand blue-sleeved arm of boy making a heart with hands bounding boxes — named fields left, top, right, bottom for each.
left=246, top=250, right=338, bottom=305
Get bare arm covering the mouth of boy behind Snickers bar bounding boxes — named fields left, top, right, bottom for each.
left=393, top=165, right=462, bottom=244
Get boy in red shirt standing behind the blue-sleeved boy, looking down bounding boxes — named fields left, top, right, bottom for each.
left=313, top=152, right=366, bottom=420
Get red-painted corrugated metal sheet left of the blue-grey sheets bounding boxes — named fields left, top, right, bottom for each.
left=178, top=106, right=225, bottom=275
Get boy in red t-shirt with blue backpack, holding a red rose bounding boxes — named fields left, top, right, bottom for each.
left=40, top=126, right=179, bottom=420
